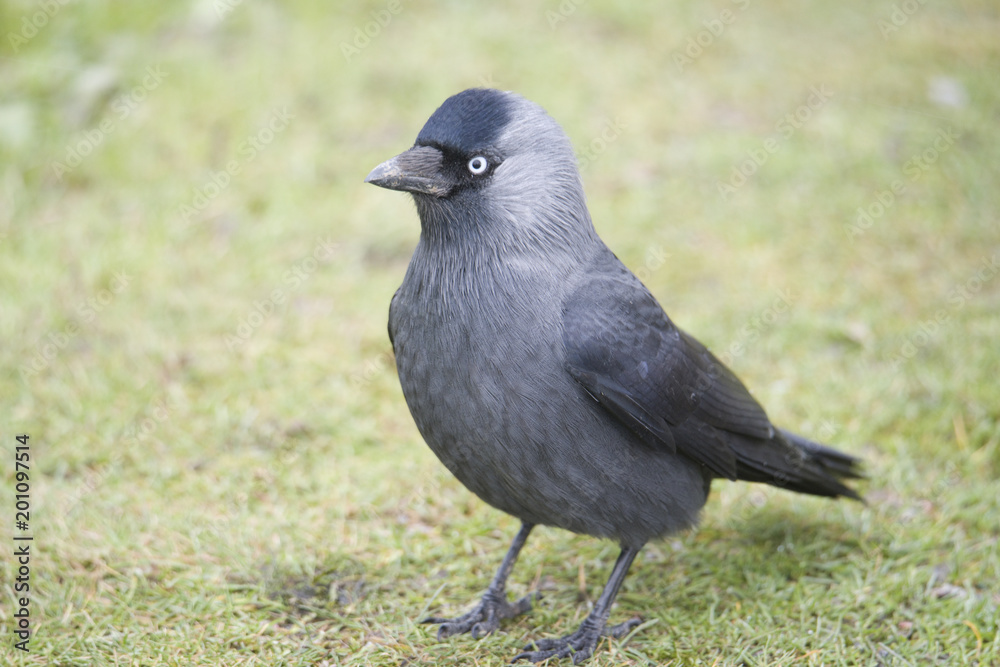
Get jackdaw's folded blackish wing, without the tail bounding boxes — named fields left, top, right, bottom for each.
left=563, top=258, right=774, bottom=479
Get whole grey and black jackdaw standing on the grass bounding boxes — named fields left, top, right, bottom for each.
left=365, top=88, right=863, bottom=664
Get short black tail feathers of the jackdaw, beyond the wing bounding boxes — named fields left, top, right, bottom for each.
left=733, top=429, right=864, bottom=500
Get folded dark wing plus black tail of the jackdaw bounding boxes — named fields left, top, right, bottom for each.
left=563, top=253, right=861, bottom=499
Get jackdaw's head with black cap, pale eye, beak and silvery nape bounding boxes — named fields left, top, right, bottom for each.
left=365, top=88, right=594, bottom=253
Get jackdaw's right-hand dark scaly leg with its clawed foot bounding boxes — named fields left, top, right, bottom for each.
left=514, top=547, right=642, bottom=665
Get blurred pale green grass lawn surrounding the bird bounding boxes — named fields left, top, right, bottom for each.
left=0, top=0, right=1000, bottom=665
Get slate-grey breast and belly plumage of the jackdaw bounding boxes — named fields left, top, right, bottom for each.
left=390, top=253, right=706, bottom=544
